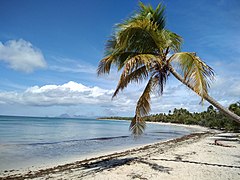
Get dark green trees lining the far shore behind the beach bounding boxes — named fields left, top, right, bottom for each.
left=100, top=102, right=240, bottom=132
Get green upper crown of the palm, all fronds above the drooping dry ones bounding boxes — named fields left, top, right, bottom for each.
left=97, top=3, right=181, bottom=75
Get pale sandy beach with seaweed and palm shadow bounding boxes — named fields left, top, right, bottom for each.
left=0, top=129, right=240, bottom=180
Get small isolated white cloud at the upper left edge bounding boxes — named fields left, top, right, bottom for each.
left=0, top=39, right=46, bottom=73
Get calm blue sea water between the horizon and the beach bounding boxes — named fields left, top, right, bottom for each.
left=0, top=116, right=191, bottom=171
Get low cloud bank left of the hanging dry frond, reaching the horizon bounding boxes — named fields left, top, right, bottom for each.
left=0, top=81, right=137, bottom=116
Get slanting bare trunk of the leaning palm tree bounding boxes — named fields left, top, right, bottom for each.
left=169, top=66, right=240, bottom=123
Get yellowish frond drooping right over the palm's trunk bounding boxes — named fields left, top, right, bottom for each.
left=169, top=52, right=214, bottom=102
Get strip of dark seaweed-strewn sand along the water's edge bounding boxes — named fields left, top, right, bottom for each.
left=0, top=132, right=212, bottom=179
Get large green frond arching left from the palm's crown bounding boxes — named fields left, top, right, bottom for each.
left=97, top=20, right=163, bottom=75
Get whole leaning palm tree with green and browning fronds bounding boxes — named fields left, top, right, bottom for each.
left=97, top=3, right=240, bottom=135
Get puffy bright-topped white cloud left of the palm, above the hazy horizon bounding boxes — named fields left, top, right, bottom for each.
left=0, top=81, right=116, bottom=106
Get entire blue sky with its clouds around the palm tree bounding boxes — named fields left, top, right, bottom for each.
left=0, top=0, right=240, bottom=116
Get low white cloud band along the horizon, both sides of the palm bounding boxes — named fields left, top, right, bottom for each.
left=0, top=75, right=239, bottom=116
